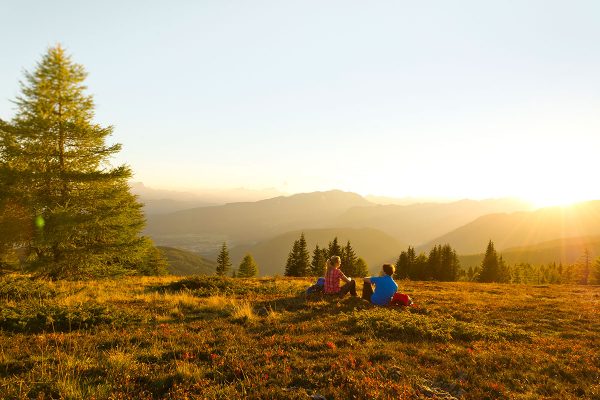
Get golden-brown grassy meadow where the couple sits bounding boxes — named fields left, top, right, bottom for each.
left=0, top=277, right=600, bottom=399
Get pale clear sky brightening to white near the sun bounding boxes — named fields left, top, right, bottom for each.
left=0, top=0, right=600, bottom=205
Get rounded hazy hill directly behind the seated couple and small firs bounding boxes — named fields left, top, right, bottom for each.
left=230, top=228, right=405, bottom=276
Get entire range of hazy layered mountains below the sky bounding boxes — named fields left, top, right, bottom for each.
left=146, top=190, right=600, bottom=275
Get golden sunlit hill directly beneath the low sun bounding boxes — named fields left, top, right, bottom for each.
left=418, top=200, right=600, bottom=254
